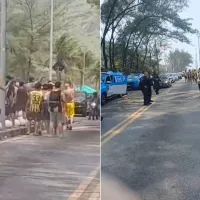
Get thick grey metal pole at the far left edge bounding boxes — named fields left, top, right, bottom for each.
left=0, top=0, right=7, bottom=128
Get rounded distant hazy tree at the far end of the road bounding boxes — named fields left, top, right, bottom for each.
left=168, top=49, right=193, bottom=72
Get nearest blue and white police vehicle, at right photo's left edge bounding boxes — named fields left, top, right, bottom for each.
left=101, top=71, right=127, bottom=105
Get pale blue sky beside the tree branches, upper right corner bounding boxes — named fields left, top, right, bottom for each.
left=100, top=0, right=200, bottom=68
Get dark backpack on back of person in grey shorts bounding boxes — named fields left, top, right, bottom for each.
left=49, top=90, right=61, bottom=112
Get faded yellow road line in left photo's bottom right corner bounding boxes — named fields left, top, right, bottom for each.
left=68, top=166, right=100, bottom=200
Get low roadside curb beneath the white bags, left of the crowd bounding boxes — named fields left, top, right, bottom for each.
left=0, top=127, right=27, bottom=141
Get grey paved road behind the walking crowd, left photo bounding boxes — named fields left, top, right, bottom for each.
left=0, top=118, right=100, bottom=200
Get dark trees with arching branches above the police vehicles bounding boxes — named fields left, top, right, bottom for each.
left=101, top=0, right=197, bottom=73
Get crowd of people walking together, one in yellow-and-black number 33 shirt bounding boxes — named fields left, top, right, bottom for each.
left=1, top=80, right=75, bottom=135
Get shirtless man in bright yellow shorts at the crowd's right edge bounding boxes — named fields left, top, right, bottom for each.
left=63, top=83, right=74, bottom=130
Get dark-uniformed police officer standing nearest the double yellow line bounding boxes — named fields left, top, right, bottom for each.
left=140, top=72, right=151, bottom=106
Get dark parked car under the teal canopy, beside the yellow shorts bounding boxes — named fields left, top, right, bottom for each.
left=74, top=91, right=88, bottom=117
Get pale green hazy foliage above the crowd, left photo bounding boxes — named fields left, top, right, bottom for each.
left=7, top=0, right=99, bottom=88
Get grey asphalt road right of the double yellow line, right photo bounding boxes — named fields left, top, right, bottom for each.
left=101, top=81, right=200, bottom=200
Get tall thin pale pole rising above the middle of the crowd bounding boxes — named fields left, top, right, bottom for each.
left=49, top=0, right=53, bottom=80
